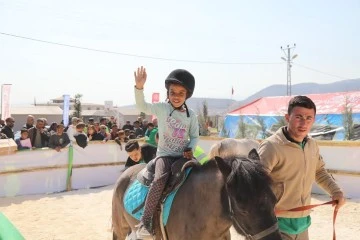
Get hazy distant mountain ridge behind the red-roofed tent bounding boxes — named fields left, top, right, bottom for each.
left=229, top=78, right=360, bottom=110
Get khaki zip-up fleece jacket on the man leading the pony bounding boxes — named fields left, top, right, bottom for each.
left=259, top=127, right=341, bottom=218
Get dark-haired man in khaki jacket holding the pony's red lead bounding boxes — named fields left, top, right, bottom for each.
left=259, top=96, right=345, bottom=240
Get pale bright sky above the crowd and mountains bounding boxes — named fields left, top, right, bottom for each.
left=0, top=0, right=360, bottom=106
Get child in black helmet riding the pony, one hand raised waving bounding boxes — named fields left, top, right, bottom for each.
left=134, top=67, right=199, bottom=236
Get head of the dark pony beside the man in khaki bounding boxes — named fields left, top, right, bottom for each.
left=215, top=154, right=281, bottom=240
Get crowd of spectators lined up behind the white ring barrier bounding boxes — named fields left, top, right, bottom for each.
left=0, top=115, right=157, bottom=151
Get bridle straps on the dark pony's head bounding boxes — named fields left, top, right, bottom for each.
left=225, top=172, right=279, bottom=240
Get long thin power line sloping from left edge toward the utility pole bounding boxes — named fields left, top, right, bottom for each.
left=0, top=32, right=282, bottom=65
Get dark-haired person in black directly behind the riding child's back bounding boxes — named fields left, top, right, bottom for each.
left=125, top=140, right=157, bottom=168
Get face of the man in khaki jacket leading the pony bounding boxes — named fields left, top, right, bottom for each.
left=285, top=107, right=315, bottom=142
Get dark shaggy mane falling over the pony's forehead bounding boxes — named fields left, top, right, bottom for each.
left=225, top=157, right=272, bottom=204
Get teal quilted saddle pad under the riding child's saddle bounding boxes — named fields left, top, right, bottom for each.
left=124, top=168, right=191, bottom=226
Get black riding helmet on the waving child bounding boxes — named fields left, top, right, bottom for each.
left=165, top=69, right=195, bottom=99
